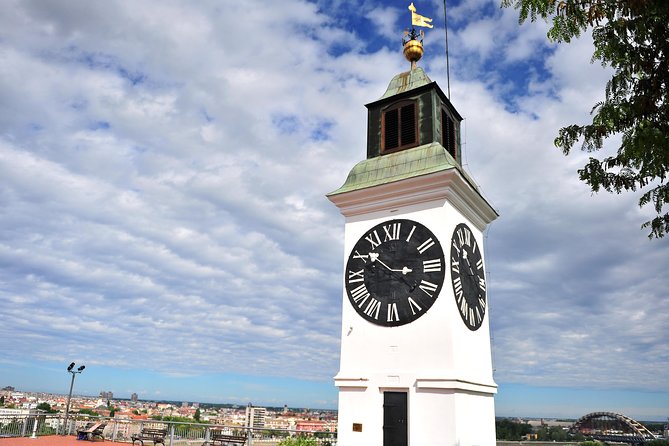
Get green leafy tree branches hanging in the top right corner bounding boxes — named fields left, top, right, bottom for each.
left=502, top=0, right=669, bottom=238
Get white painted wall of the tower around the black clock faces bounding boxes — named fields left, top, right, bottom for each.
left=333, top=168, right=496, bottom=446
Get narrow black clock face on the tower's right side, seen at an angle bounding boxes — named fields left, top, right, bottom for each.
left=451, top=223, right=486, bottom=331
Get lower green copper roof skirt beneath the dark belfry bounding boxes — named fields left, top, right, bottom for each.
left=328, top=142, right=477, bottom=195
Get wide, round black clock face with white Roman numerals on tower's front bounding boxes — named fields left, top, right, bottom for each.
left=344, top=220, right=446, bottom=327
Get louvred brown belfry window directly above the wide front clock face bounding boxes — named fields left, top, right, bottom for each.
left=381, top=101, right=418, bottom=152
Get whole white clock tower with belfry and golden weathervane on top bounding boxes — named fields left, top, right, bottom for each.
left=327, top=4, right=497, bottom=446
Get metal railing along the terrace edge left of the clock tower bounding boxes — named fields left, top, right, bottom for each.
left=0, top=414, right=337, bottom=446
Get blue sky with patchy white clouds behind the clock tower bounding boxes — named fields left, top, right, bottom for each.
left=0, top=0, right=669, bottom=420
